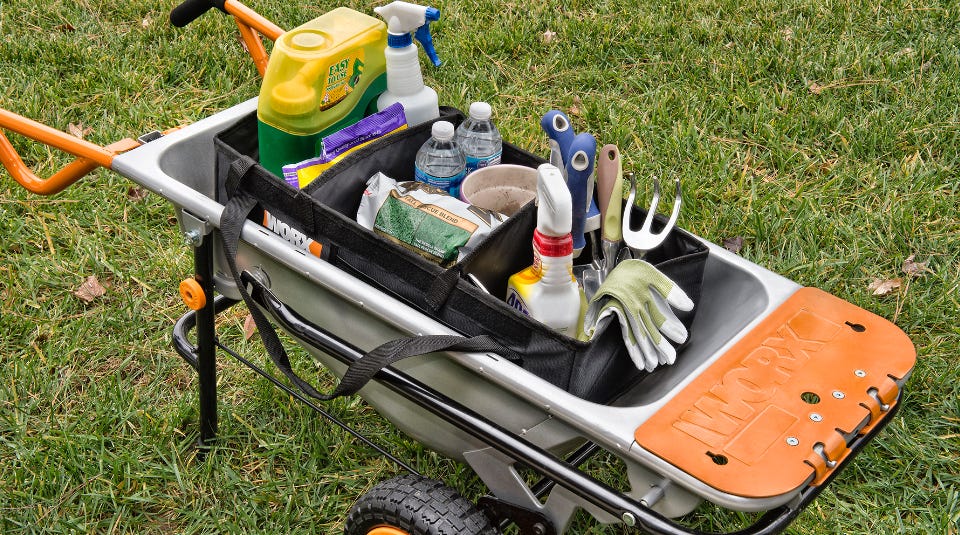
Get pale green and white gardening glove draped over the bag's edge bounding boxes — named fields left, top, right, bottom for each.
left=583, top=260, right=693, bottom=372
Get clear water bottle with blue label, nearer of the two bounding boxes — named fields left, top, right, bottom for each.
left=414, top=121, right=467, bottom=198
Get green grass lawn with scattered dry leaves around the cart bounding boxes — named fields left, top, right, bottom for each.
left=0, top=0, right=960, bottom=535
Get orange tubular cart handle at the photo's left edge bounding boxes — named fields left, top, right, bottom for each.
left=0, top=109, right=139, bottom=195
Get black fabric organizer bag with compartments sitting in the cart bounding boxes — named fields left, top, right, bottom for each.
left=215, top=107, right=708, bottom=403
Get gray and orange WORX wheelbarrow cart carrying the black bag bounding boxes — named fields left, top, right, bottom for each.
left=0, top=0, right=915, bottom=535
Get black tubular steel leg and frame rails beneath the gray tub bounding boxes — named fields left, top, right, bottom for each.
left=173, top=234, right=899, bottom=535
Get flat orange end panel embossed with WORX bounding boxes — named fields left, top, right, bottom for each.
left=635, top=288, right=916, bottom=498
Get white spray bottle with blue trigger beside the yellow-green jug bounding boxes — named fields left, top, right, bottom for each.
left=373, top=1, right=440, bottom=126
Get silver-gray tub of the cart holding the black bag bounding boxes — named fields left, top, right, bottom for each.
left=113, top=100, right=906, bottom=526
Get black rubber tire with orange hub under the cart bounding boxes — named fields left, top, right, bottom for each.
left=343, top=474, right=498, bottom=535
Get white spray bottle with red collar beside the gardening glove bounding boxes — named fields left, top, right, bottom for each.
left=507, top=164, right=581, bottom=337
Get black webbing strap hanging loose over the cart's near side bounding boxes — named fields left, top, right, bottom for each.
left=220, top=156, right=520, bottom=401
